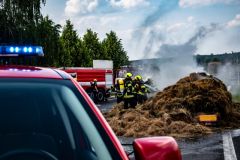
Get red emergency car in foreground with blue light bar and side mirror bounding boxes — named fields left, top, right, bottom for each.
left=0, top=45, right=181, bottom=160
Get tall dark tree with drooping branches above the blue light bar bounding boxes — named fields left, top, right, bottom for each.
left=0, top=0, right=45, bottom=44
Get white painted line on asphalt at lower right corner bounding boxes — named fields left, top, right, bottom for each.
left=222, top=132, right=237, bottom=160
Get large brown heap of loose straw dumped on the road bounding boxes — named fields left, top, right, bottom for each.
left=104, top=73, right=240, bottom=138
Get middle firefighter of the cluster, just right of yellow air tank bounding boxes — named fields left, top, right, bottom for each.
left=123, top=72, right=137, bottom=109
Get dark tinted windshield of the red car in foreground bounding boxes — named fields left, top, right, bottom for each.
left=0, top=79, right=115, bottom=160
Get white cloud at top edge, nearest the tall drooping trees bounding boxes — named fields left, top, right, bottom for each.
left=65, top=0, right=98, bottom=16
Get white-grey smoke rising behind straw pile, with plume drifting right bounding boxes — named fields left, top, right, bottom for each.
left=131, top=24, right=221, bottom=89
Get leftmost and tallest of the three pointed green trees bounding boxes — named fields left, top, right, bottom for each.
left=60, top=20, right=79, bottom=66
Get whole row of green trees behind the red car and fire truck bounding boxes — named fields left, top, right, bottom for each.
left=0, top=0, right=128, bottom=68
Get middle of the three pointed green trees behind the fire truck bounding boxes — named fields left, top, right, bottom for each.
left=82, top=29, right=103, bottom=67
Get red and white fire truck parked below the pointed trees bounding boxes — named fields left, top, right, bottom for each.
left=62, top=67, right=113, bottom=102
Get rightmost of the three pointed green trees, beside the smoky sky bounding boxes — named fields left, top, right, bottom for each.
left=102, top=31, right=128, bottom=69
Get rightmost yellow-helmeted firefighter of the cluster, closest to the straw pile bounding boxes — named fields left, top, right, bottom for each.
left=134, top=75, right=148, bottom=104
